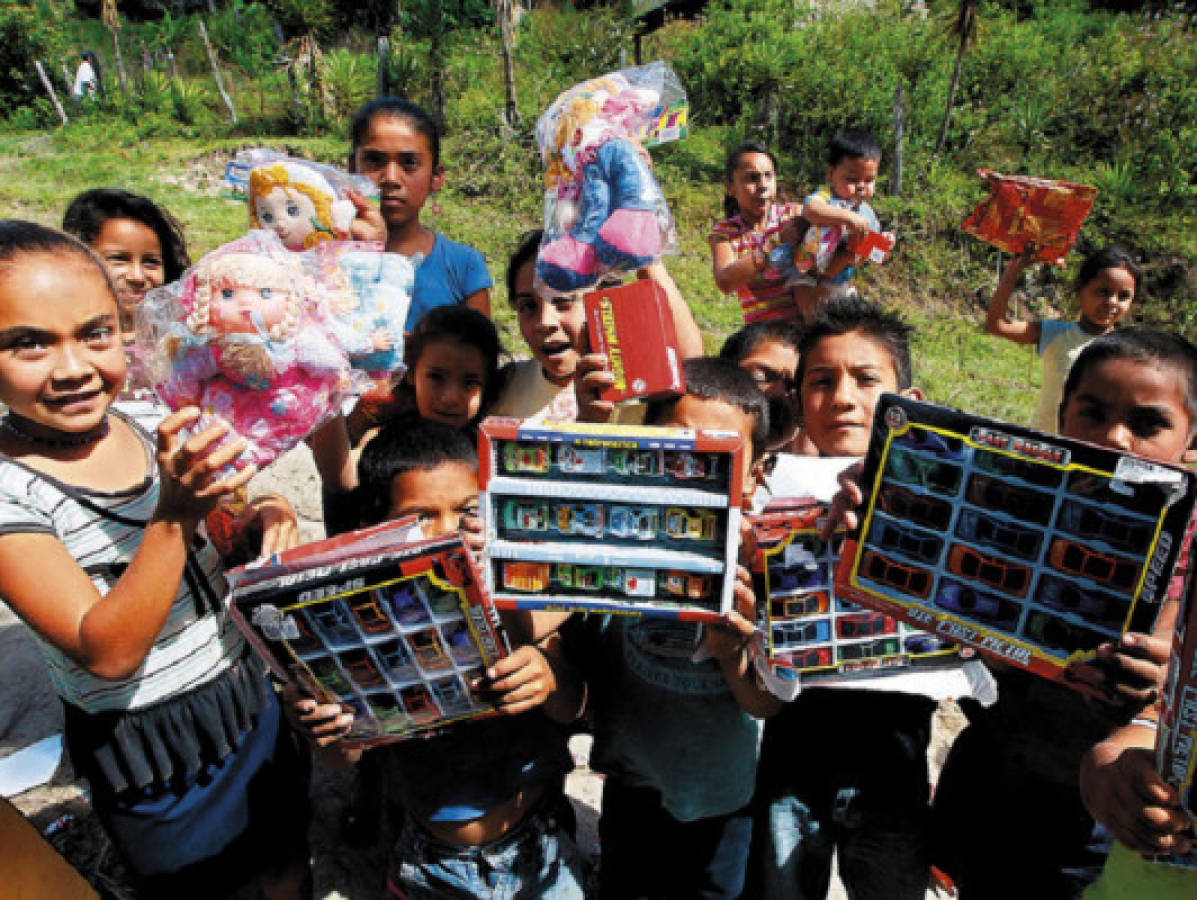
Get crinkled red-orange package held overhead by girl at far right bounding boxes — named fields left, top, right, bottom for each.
left=960, top=169, right=1098, bottom=266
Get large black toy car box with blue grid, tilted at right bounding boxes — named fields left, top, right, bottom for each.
left=836, top=394, right=1195, bottom=688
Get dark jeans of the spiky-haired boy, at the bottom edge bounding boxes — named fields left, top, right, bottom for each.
left=758, top=789, right=930, bottom=900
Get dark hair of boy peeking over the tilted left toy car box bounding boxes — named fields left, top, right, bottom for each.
left=354, top=416, right=478, bottom=525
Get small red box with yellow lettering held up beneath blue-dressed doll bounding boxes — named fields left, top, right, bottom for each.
left=583, top=279, right=686, bottom=403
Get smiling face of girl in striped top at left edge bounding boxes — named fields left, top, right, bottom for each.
left=0, top=254, right=124, bottom=433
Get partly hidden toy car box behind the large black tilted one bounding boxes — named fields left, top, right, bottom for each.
left=751, top=501, right=959, bottom=699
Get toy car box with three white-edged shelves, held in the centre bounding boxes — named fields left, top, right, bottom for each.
left=479, top=418, right=746, bottom=621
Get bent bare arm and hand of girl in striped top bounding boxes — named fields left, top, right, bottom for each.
left=0, top=407, right=256, bottom=679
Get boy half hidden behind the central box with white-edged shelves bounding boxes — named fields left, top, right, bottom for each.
left=564, top=358, right=776, bottom=900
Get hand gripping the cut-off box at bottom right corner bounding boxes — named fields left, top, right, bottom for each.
left=1081, top=725, right=1192, bottom=855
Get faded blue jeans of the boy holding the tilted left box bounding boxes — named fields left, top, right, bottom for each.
left=387, top=797, right=584, bottom=900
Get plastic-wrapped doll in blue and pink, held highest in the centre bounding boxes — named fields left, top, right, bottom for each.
left=536, top=62, right=688, bottom=291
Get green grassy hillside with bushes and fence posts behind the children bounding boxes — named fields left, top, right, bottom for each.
left=0, top=0, right=1197, bottom=419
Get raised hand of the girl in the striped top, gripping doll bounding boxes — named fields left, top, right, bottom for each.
left=154, top=406, right=257, bottom=524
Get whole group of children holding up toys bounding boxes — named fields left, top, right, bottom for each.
left=0, top=93, right=1197, bottom=898
